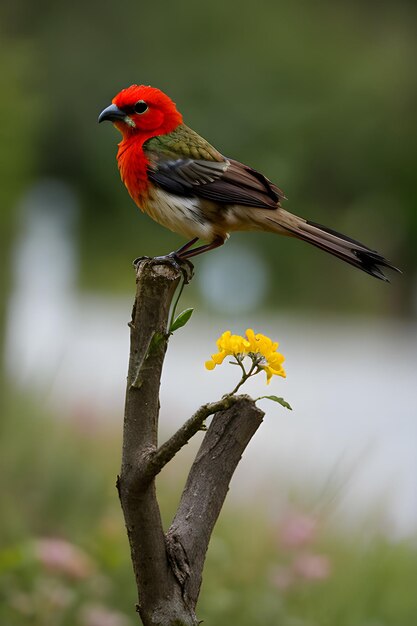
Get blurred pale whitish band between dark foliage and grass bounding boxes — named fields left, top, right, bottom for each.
left=6, top=185, right=417, bottom=536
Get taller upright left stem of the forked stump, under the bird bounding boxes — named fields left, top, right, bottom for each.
left=117, top=259, right=197, bottom=626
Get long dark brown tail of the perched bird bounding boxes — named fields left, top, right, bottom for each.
left=267, top=210, right=401, bottom=282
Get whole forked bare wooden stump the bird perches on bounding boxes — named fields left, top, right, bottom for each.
left=117, top=258, right=263, bottom=626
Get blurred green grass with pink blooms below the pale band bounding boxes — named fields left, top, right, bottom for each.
left=0, top=390, right=417, bottom=626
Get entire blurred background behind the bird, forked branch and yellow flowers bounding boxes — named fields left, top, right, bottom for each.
left=0, top=0, right=417, bottom=626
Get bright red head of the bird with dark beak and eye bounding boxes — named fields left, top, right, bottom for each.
left=98, top=85, right=182, bottom=140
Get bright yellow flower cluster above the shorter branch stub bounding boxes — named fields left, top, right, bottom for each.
left=206, top=328, right=286, bottom=383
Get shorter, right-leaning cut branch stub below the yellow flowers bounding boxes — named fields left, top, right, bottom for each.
left=167, top=396, right=264, bottom=606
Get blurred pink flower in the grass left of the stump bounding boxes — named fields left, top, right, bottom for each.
left=34, top=538, right=95, bottom=579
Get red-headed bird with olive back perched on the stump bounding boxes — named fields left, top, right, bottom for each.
left=98, top=85, right=397, bottom=280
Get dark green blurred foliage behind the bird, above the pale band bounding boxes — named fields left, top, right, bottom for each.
left=0, top=0, right=417, bottom=315
